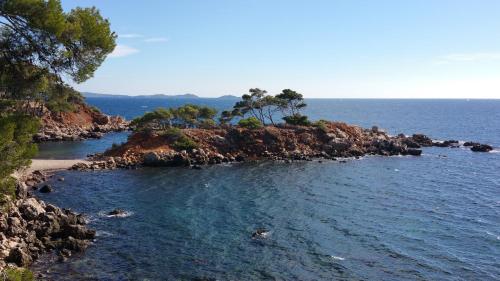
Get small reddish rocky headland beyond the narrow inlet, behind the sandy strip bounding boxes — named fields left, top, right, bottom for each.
left=34, top=101, right=129, bottom=142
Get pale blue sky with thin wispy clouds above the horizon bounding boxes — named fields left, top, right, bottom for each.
left=62, top=0, right=500, bottom=98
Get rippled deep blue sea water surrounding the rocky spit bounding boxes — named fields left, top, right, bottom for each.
left=35, top=98, right=500, bottom=280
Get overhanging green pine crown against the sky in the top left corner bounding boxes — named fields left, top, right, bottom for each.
left=0, top=0, right=116, bottom=83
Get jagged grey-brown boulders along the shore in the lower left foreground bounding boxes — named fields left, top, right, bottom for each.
left=0, top=172, right=95, bottom=271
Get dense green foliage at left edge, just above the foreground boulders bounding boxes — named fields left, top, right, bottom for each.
left=0, top=115, right=39, bottom=203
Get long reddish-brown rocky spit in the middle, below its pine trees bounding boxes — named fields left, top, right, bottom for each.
left=69, top=122, right=492, bottom=170
